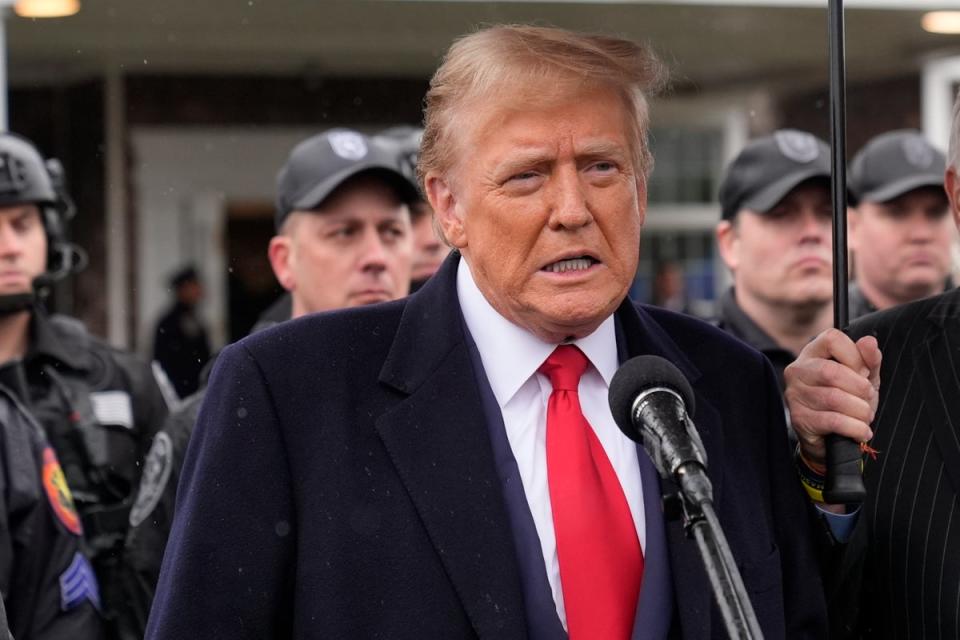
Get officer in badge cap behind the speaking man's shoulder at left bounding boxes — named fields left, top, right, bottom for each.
left=124, top=129, right=419, bottom=639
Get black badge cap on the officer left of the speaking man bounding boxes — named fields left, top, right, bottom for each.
left=275, top=129, right=418, bottom=229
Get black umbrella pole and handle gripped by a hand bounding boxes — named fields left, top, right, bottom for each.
left=823, top=0, right=866, bottom=504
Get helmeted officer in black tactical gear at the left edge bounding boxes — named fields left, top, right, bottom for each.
left=0, top=133, right=167, bottom=637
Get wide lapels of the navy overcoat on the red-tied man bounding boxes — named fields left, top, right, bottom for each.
left=377, top=254, right=723, bottom=638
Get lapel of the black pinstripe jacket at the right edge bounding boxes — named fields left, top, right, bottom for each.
left=920, top=289, right=960, bottom=493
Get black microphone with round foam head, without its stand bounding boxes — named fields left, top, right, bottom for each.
left=608, top=356, right=713, bottom=504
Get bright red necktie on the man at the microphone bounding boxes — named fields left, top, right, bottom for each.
left=540, top=345, right=643, bottom=640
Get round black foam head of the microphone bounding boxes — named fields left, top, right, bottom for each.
left=607, top=356, right=695, bottom=438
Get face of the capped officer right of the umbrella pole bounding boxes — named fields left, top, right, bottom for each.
left=849, top=188, right=954, bottom=302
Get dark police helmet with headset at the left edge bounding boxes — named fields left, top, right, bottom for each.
left=0, top=132, right=86, bottom=284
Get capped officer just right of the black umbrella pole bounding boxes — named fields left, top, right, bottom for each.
left=847, top=129, right=956, bottom=320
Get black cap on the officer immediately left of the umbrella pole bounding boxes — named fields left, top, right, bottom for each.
left=720, top=129, right=830, bottom=220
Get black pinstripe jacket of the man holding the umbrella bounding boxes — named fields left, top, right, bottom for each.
left=831, top=289, right=960, bottom=638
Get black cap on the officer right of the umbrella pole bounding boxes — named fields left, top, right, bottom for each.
left=847, top=129, right=947, bottom=204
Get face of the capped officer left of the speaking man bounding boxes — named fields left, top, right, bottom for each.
left=269, top=177, right=413, bottom=317
